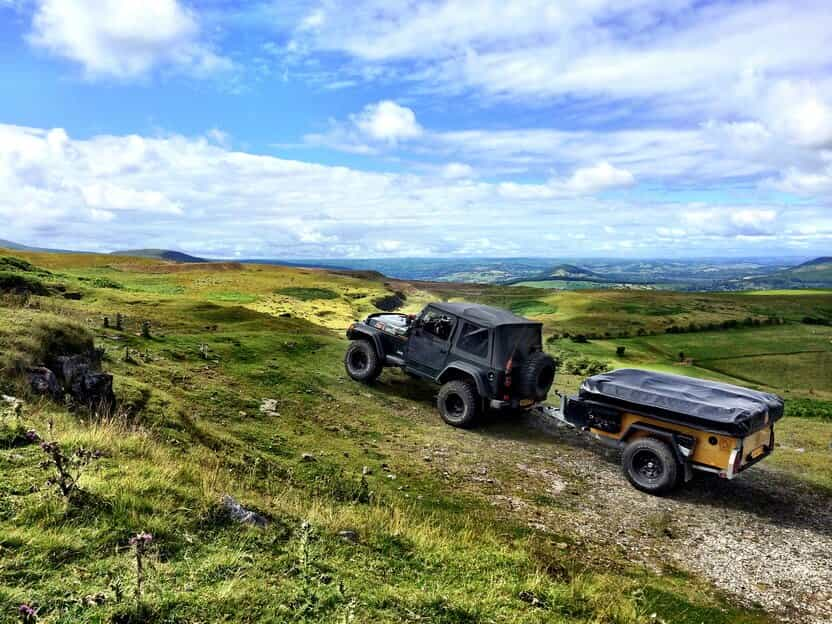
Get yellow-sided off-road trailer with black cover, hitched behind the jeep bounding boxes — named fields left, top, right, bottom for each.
left=541, top=368, right=783, bottom=495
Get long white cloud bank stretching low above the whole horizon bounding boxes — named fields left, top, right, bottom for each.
left=0, top=120, right=832, bottom=258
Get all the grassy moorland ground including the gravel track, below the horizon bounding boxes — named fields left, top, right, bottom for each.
left=0, top=250, right=832, bottom=624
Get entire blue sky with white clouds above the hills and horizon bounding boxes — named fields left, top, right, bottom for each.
left=0, top=0, right=832, bottom=258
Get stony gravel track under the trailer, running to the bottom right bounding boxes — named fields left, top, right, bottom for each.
left=412, top=404, right=832, bottom=624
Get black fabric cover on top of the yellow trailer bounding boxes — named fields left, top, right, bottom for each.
left=579, top=368, right=783, bottom=436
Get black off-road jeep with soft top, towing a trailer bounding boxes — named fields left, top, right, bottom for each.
left=344, top=303, right=555, bottom=427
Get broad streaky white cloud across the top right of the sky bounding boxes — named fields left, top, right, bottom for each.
left=290, top=0, right=832, bottom=114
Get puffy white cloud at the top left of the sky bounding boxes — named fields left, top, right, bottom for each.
left=28, top=0, right=232, bottom=79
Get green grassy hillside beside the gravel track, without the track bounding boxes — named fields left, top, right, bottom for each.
left=0, top=252, right=832, bottom=624
